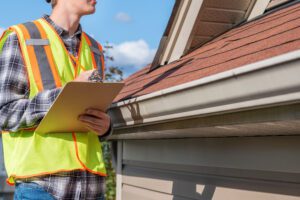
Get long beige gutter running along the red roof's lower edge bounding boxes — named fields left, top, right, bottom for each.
left=109, top=50, right=300, bottom=127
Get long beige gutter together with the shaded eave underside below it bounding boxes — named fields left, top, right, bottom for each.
left=109, top=50, right=300, bottom=139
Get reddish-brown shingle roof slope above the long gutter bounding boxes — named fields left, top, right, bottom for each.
left=114, top=3, right=300, bottom=102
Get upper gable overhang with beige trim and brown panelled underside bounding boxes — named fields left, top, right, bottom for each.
left=150, top=0, right=270, bottom=70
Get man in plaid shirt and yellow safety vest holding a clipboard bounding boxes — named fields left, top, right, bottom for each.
left=0, top=0, right=112, bottom=200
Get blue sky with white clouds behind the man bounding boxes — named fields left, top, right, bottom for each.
left=0, top=0, right=175, bottom=76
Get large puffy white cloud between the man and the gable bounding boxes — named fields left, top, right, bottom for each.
left=108, top=39, right=156, bottom=71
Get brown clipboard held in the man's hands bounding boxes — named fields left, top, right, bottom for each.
left=35, top=82, right=124, bottom=134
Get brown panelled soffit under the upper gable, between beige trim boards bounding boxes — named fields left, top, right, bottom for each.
left=185, top=0, right=256, bottom=53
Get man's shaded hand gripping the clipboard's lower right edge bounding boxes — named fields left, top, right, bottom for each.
left=79, top=108, right=110, bottom=136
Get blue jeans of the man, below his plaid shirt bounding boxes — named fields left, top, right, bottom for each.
left=14, top=183, right=55, bottom=200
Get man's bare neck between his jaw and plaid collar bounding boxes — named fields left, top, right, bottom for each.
left=50, top=9, right=81, bottom=36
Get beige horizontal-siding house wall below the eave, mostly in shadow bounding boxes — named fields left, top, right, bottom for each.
left=117, top=136, right=300, bottom=200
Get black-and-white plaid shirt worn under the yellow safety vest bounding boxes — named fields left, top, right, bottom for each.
left=0, top=15, right=108, bottom=200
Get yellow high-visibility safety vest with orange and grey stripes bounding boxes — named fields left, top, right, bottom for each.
left=0, top=19, right=106, bottom=185
